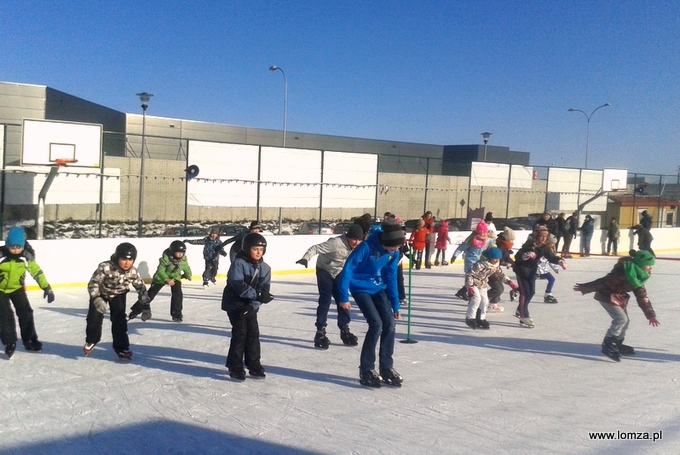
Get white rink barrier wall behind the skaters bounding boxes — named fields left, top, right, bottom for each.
left=26, top=228, right=680, bottom=289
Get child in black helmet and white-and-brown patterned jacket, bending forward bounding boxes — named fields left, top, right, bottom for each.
left=83, top=242, right=150, bottom=359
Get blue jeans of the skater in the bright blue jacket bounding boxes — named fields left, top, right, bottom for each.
left=352, top=290, right=395, bottom=372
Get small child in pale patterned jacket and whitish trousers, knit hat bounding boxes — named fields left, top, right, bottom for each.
left=465, top=247, right=517, bottom=329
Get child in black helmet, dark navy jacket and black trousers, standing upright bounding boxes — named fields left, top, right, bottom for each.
left=222, top=232, right=274, bottom=381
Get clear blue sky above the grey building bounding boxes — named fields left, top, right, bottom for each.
left=0, top=0, right=680, bottom=174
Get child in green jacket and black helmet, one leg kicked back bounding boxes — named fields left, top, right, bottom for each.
left=128, top=240, right=191, bottom=322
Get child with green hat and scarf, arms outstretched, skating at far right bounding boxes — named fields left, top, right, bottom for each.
left=574, top=250, right=659, bottom=362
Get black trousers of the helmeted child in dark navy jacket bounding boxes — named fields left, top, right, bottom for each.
left=227, top=305, right=261, bottom=369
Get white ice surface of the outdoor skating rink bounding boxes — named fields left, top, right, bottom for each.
left=0, top=257, right=680, bottom=455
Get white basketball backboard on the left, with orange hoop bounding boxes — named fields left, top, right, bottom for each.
left=21, top=119, right=103, bottom=167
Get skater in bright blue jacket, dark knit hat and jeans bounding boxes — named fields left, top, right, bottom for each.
left=338, top=218, right=405, bottom=387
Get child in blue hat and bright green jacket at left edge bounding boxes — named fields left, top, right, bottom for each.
left=0, top=226, right=54, bottom=358
